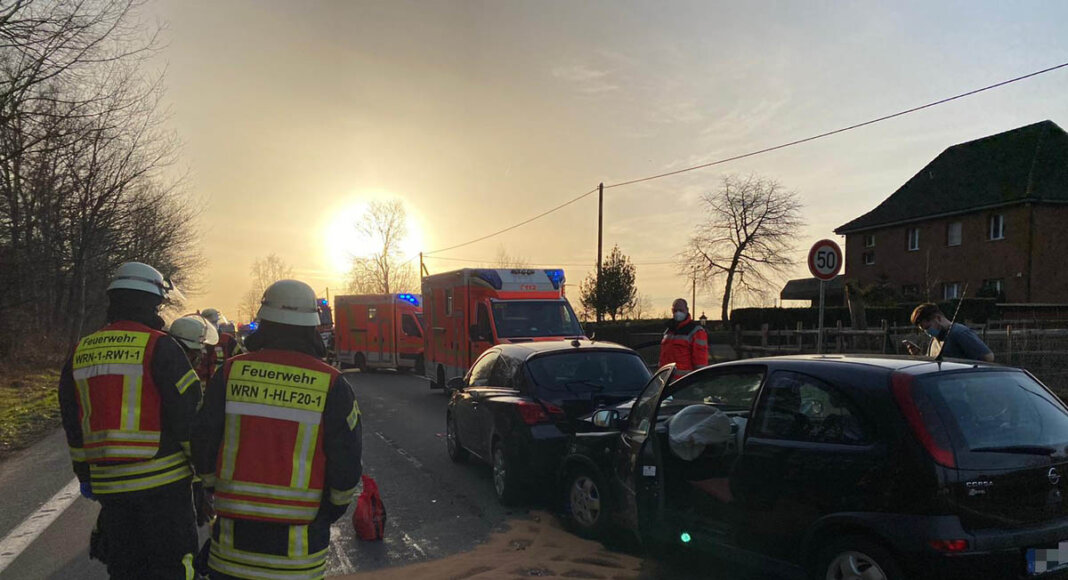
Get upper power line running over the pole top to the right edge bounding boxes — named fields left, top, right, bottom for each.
left=424, top=62, right=1068, bottom=256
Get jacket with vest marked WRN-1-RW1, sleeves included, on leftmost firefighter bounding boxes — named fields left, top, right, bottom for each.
left=59, top=320, right=201, bottom=496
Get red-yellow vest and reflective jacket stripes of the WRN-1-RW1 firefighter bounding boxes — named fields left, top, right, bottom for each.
left=70, top=322, right=198, bottom=495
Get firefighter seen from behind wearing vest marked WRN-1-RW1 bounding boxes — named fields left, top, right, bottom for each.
left=59, top=262, right=201, bottom=579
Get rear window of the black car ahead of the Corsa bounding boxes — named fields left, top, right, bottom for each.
left=527, top=350, right=649, bottom=398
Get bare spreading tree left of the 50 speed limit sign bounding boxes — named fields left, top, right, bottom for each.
left=680, top=175, right=804, bottom=320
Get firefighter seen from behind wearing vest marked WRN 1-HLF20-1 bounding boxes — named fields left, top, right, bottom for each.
left=192, top=280, right=362, bottom=578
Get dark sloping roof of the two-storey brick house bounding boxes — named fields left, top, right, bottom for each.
left=834, top=121, right=1068, bottom=235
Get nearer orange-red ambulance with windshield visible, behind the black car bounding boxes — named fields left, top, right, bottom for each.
left=423, top=268, right=583, bottom=393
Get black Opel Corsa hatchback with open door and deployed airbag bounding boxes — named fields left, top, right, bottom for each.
left=562, top=356, right=1068, bottom=580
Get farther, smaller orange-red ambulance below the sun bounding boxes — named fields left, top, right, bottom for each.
left=333, top=294, right=423, bottom=373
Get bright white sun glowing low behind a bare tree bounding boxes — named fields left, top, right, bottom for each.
left=323, top=195, right=424, bottom=276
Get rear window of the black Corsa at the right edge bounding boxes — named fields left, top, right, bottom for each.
left=920, top=371, right=1068, bottom=459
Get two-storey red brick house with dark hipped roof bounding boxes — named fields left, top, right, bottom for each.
left=834, top=121, right=1068, bottom=303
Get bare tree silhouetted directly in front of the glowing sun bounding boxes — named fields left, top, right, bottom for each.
left=348, top=200, right=417, bottom=294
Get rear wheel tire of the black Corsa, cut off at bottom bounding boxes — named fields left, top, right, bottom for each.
left=810, top=535, right=905, bottom=580
